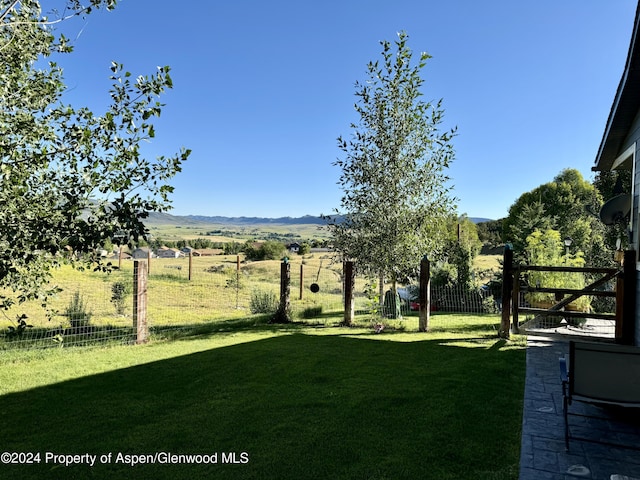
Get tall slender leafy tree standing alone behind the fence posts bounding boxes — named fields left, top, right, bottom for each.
left=328, top=32, right=455, bottom=304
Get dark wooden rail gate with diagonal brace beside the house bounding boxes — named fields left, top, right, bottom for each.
left=502, top=250, right=636, bottom=343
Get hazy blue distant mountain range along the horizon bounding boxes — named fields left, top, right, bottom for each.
left=145, top=212, right=490, bottom=226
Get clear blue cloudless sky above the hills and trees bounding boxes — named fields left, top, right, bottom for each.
left=53, top=0, right=636, bottom=219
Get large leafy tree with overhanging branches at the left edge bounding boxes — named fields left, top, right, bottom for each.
left=0, top=0, right=189, bottom=308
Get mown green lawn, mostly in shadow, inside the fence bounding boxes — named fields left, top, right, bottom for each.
left=0, top=315, right=525, bottom=480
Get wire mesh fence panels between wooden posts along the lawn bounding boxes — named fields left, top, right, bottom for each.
left=0, top=252, right=495, bottom=349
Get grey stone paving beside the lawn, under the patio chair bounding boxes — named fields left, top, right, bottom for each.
left=520, top=336, right=640, bottom=480
